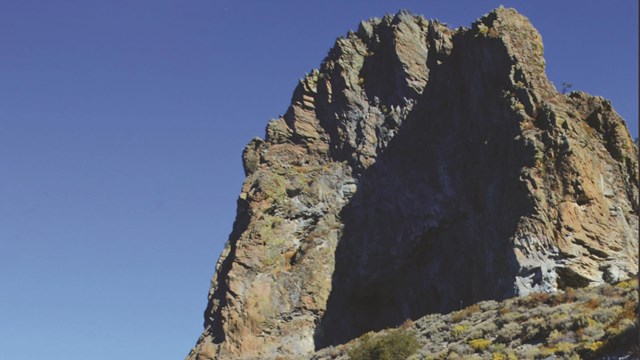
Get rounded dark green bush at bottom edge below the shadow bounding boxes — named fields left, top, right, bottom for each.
left=349, top=329, right=420, bottom=360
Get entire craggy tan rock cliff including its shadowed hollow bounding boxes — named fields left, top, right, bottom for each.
left=188, top=8, right=638, bottom=360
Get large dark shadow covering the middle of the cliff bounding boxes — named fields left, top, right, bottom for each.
left=315, top=34, right=532, bottom=349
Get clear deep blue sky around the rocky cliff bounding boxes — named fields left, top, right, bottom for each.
left=0, top=0, right=638, bottom=360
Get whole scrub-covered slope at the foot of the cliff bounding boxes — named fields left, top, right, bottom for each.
left=318, top=278, right=638, bottom=360
